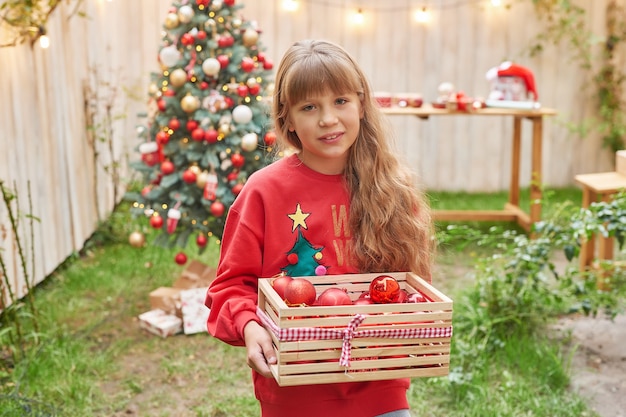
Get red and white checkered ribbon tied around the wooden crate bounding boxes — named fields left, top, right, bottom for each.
left=257, top=307, right=452, bottom=367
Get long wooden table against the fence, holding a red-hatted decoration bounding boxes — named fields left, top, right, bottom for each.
left=382, top=105, right=556, bottom=231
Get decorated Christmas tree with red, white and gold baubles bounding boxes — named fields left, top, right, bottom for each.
left=127, top=0, right=275, bottom=263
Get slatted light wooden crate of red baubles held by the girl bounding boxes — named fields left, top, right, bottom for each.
left=258, top=272, right=452, bottom=386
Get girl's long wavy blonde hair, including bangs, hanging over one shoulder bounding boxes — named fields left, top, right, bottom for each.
left=272, top=40, right=433, bottom=280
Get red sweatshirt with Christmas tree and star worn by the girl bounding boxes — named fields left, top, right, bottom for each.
left=206, top=155, right=409, bottom=417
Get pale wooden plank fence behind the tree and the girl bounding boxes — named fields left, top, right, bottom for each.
left=0, top=0, right=624, bottom=302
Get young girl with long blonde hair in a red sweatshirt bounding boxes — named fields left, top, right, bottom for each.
left=206, top=41, right=432, bottom=417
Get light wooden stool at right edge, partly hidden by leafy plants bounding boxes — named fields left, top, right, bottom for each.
left=574, top=172, right=626, bottom=271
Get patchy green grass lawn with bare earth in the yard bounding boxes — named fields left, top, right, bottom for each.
left=0, top=189, right=608, bottom=417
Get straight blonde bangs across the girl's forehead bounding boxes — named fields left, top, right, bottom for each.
left=285, top=57, right=363, bottom=105
